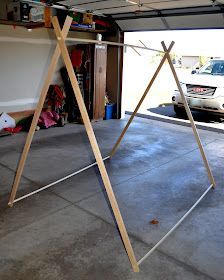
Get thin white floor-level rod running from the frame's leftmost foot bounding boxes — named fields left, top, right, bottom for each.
left=13, top=156, right=110, bottom=203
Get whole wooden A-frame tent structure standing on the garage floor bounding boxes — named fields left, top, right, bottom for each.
left=8, top=17, right=215, bottom=272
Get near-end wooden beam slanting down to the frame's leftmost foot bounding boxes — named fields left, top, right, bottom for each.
left=8, top=17, right=72, bottom=207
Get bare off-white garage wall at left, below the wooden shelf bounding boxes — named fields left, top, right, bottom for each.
left=0, top=42, right=64, bottom=112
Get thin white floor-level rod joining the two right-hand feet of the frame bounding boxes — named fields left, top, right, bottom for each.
left=138, top=184, right=213, bottom=265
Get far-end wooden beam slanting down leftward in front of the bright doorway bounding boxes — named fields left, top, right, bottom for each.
left=110, top=42, right=174, bottom=157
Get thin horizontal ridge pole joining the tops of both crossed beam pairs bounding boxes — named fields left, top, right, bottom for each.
left=65, top=38, right=165, bottom=53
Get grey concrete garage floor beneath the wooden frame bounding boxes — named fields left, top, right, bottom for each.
left=0, top=118, right=224, bottom=280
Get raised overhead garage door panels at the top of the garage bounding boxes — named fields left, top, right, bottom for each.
left=54, top=0, right=224, bottom=31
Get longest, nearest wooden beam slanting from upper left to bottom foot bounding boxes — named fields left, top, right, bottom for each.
left=52, top=17, right=139, bottom=272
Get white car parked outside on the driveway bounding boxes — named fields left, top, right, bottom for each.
left=172, top=59, right=224, bottom=115
